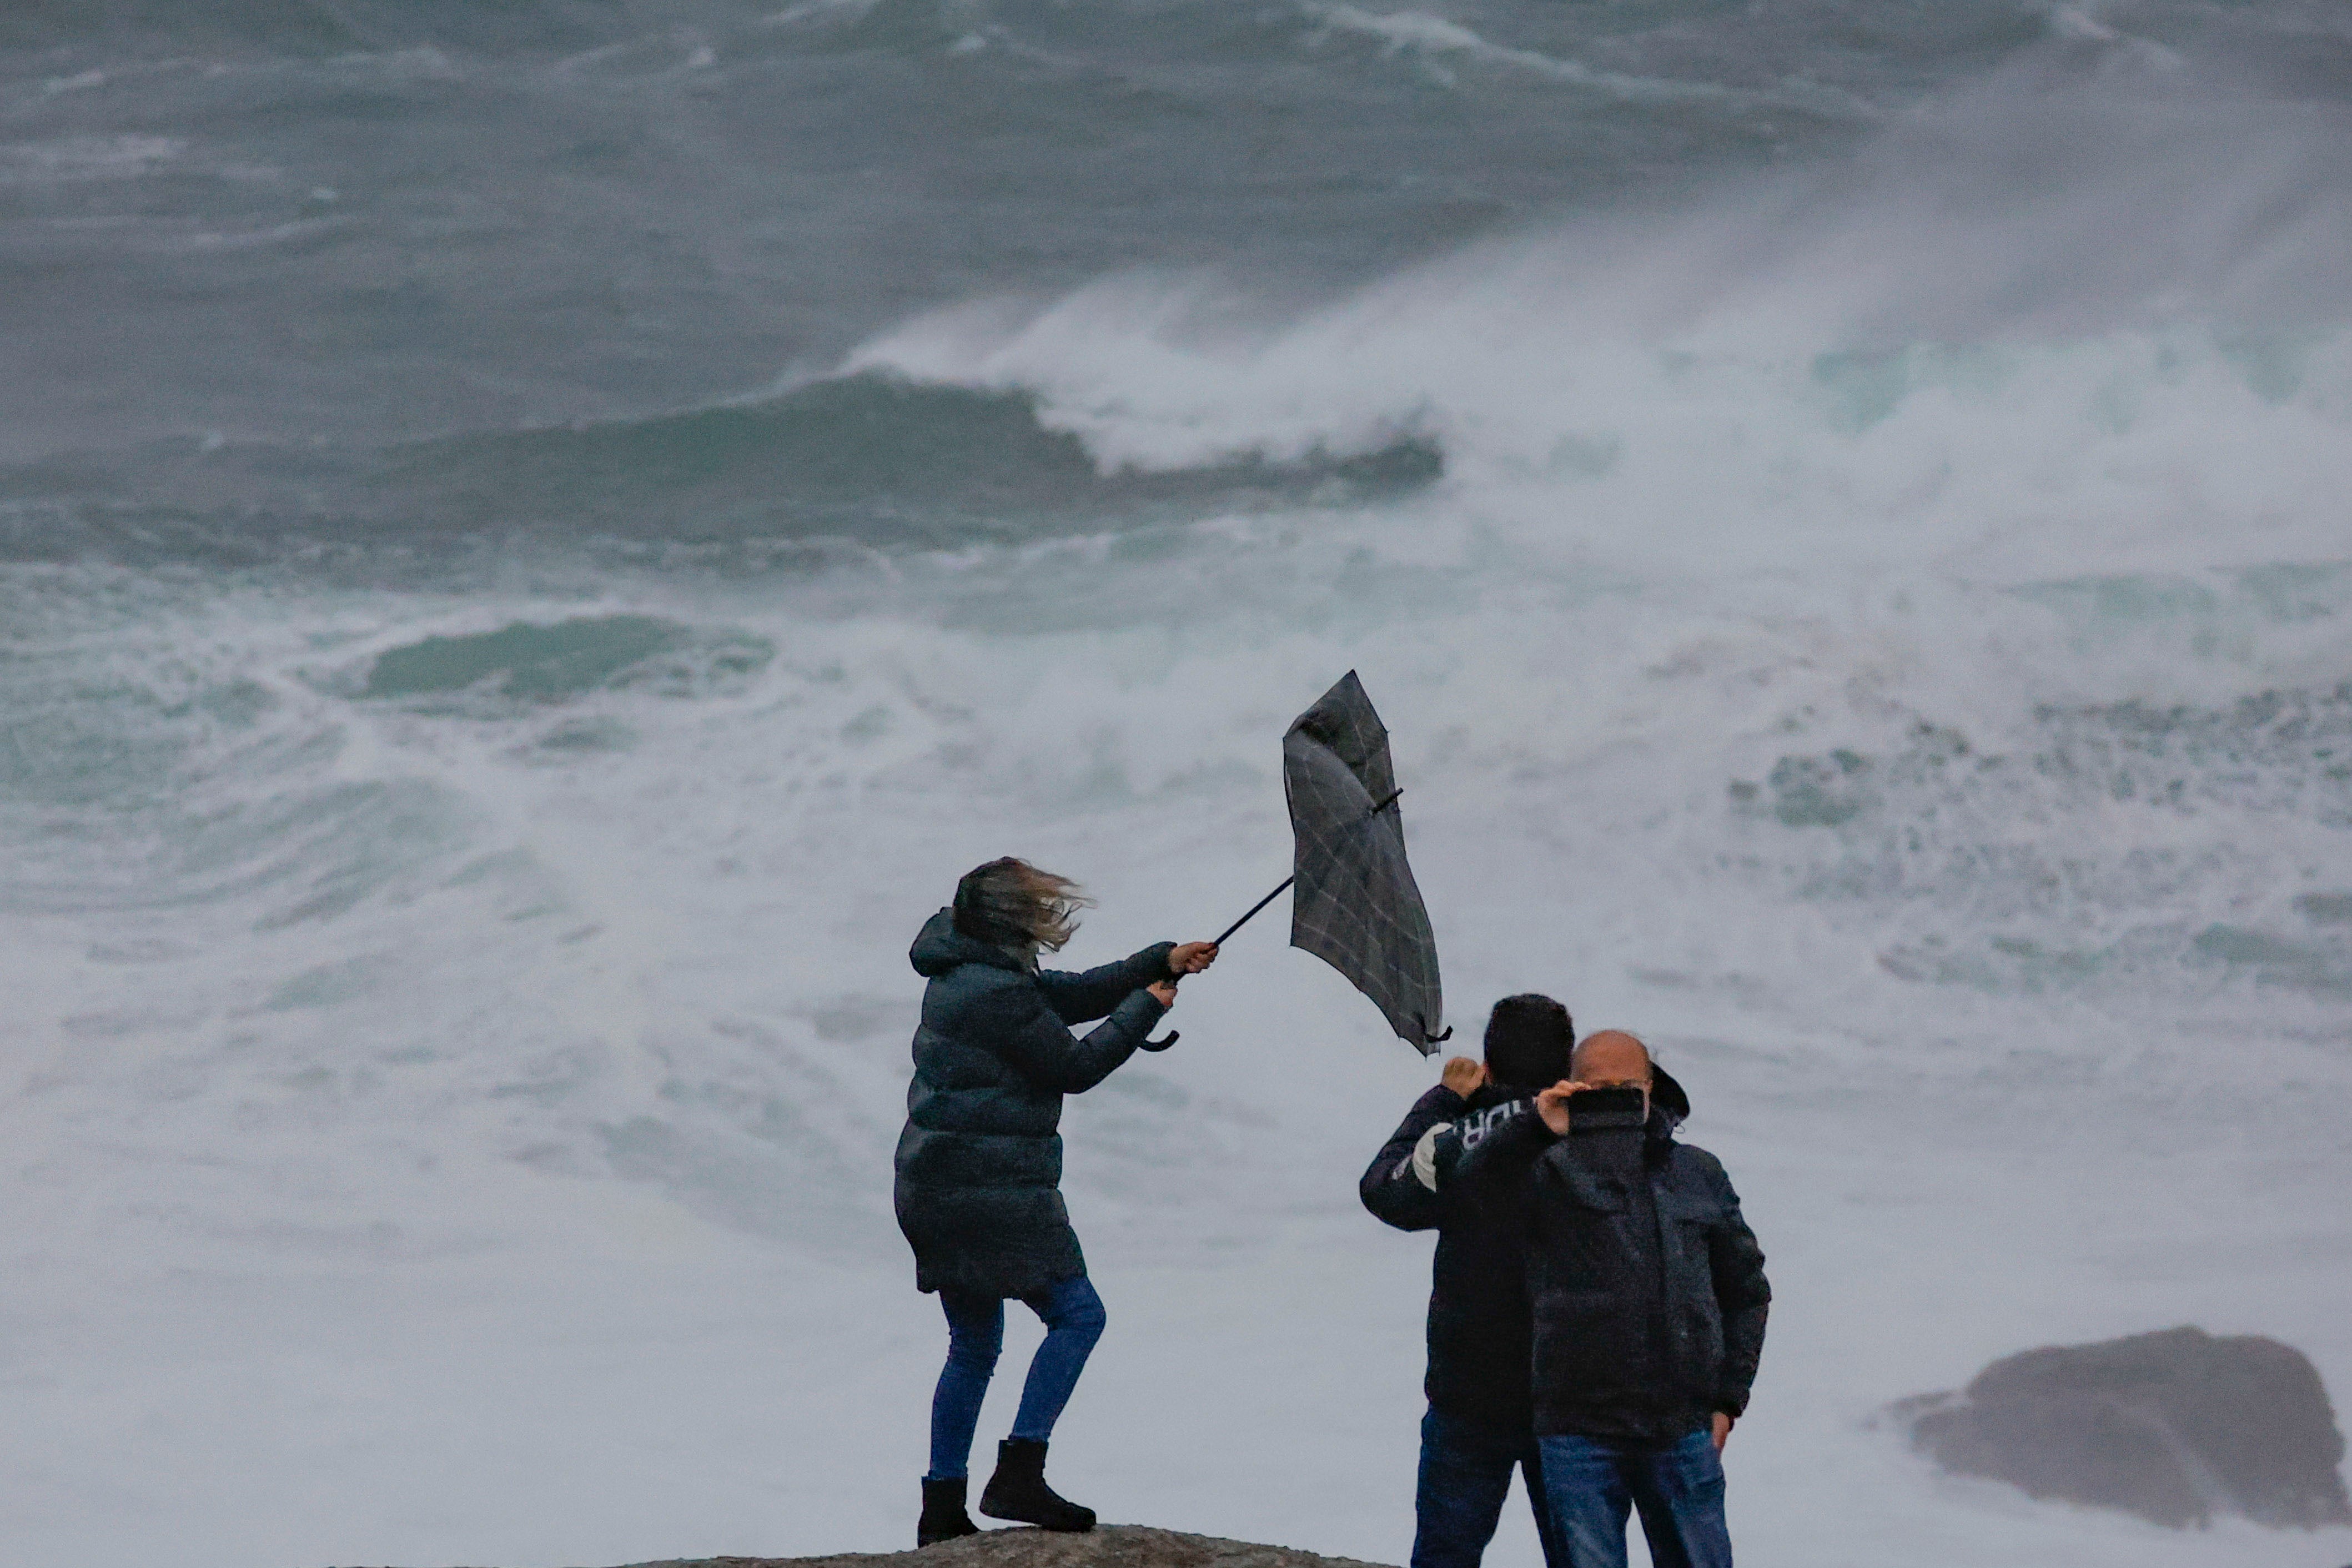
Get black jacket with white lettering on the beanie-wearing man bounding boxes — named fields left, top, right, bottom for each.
left=1357, top=1084, right=1534, bottom=1431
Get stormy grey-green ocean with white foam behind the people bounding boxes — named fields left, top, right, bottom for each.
left=0, top=0, right=2352, bottom=1568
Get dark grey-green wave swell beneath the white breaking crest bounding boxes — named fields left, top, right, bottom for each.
left=0, top=374, right=1444, bottom=562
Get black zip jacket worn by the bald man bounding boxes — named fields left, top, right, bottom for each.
left=1454, top=1100, right=1771, bottom=1446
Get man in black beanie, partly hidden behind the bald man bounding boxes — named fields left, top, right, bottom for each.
left=1357, top=994, right=1571, bottom=1568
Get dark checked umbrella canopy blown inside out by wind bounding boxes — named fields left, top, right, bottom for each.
left=1282, top=670, right=1451, bottom=1056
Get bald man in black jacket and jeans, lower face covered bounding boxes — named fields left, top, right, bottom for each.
left=1454, top=1029, right=1771, bottom=1568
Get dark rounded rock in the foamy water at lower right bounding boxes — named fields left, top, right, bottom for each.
left=1893, top=1328, right=2352, bottom=1528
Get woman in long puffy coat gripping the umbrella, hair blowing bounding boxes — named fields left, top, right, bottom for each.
left=896, top=858, right=1216, bottom=1547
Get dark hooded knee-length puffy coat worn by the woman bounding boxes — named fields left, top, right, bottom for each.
left=896, top=910, right=1174, bottom=1298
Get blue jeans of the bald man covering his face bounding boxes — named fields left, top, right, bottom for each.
left=1536, top=1431, right=1731, bottom=1568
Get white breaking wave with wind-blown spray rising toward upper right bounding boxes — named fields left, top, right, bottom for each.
left=847, top=51, right=2352, bottom=583
